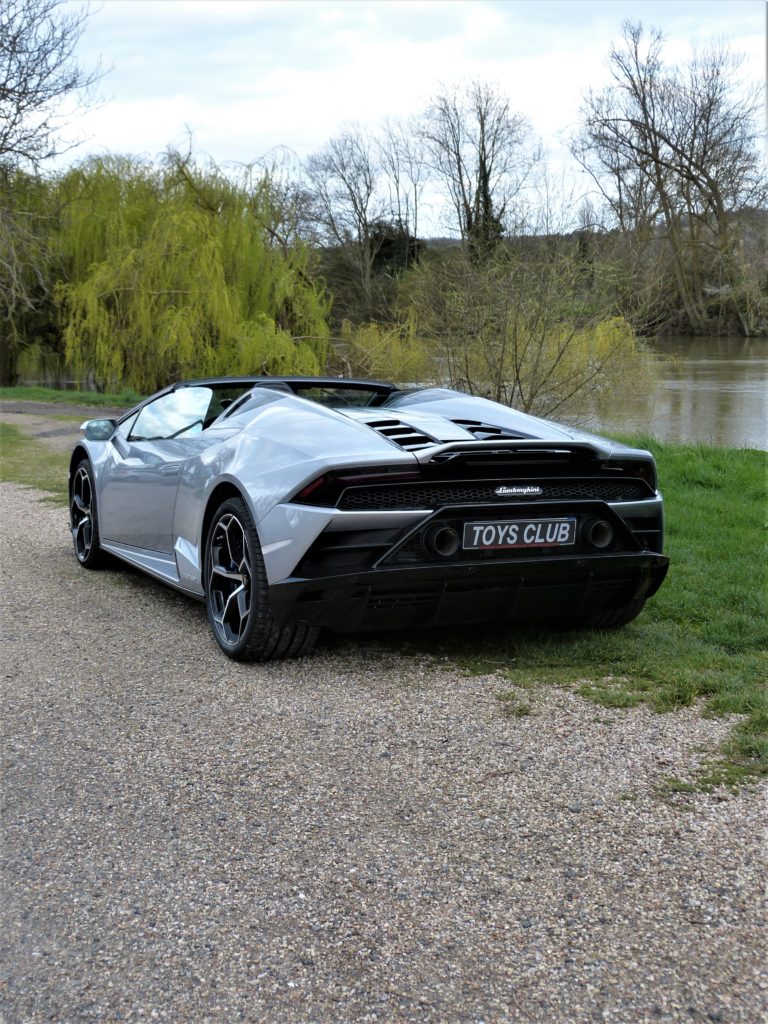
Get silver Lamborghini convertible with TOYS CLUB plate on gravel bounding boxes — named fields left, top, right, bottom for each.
left=70, top=377, right=668, bottom=658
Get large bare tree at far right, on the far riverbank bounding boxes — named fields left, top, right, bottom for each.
left=572, top=23, right=768, bottom=333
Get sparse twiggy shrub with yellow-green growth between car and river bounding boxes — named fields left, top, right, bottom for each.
left=403, top=241, right=650, bottom=415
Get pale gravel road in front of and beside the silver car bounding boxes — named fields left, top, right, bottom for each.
left=0, top=484, right=768, bottom=1024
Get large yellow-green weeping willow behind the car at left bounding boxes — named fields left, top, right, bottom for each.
left=57, top=154, right=328, bottom=391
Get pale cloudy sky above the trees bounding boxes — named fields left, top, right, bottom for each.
left=65, top=0, right=766, bottom=228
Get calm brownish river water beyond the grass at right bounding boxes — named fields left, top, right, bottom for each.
left=568, top=338, right=768, bottom=450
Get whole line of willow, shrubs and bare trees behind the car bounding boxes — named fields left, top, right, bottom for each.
left=0, top=14, right=768, bottom=413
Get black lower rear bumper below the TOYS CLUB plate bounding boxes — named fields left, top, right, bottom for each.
left=269, top=552, right=669, bottom=633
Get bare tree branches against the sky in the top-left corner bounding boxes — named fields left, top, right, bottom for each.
left=0, top=0, right=99, bottom=167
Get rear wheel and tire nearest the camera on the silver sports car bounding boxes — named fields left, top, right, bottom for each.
left=205, top=498, right=319, bottom=662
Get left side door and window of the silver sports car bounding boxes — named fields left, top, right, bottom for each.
left=99, top=386, right=217, bottom=553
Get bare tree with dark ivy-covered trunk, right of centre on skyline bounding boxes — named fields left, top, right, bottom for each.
left=419, top=82, right=536, bottom=256
